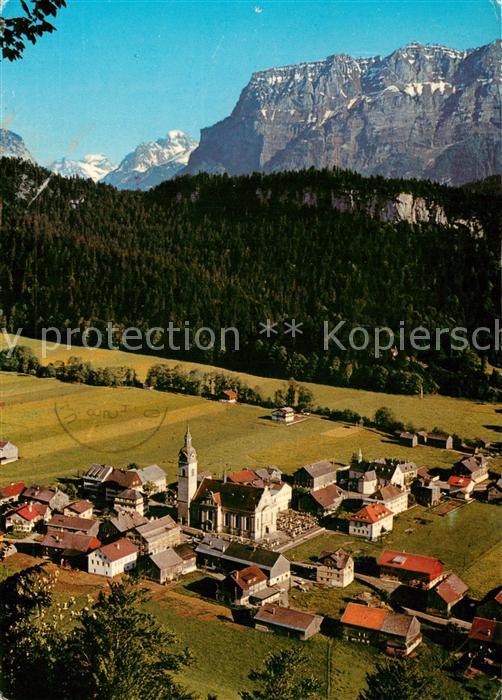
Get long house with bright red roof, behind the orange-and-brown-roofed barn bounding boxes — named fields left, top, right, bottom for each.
left=377, top=549, right=444, bottom=590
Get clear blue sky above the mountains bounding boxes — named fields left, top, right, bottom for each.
left=0, top=0, right=500, bottom=163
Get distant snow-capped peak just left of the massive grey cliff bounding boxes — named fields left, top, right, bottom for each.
left=103, top=130, right=197, bottom=190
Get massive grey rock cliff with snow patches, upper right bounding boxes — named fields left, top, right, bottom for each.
left=181, top=42, right=502, bottom=184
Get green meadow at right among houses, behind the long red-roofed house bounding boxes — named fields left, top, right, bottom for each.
left=287, top=502, right=502, bottom=598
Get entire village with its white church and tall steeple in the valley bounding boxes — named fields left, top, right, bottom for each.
left=0, top=400, right=502, bottom=688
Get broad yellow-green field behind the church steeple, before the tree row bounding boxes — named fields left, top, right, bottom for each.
left=0, top=372, right=476, bottom=490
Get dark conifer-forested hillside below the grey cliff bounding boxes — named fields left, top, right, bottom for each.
left=0, top=159, right=502, bottom=400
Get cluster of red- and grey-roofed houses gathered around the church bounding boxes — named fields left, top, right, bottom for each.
left=0, top=422, right=502, bottom=668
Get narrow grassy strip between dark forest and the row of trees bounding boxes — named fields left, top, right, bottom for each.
left=0, top=335, right=500, bottom=440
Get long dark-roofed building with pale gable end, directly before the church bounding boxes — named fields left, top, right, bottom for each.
left=195, top=535, right=291, bottom=590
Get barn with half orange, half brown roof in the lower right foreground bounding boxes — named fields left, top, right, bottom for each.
left=340, top=603, right=422, bottom=656
